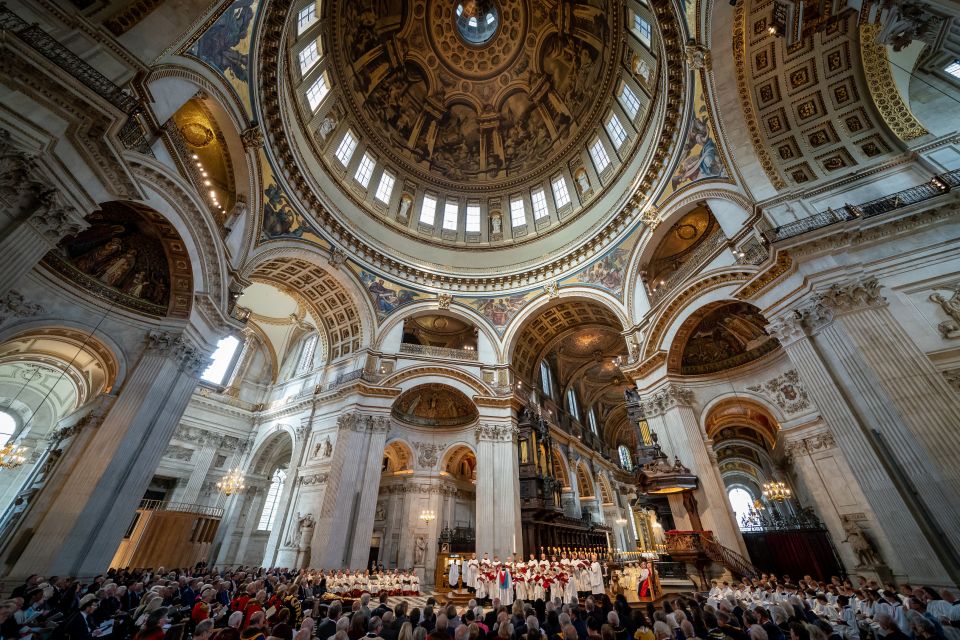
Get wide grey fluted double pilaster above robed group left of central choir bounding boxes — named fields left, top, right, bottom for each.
left=312, top=413, right=390, bottom=569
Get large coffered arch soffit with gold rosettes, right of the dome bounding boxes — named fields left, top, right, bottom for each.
left=724, top=0, right=902, bottom=190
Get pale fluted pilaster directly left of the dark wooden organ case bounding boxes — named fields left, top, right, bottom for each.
left=476, top=423, right=523, bottom=558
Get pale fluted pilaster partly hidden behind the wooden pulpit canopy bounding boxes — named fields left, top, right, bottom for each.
left=641, top=383, right=747, bottom=556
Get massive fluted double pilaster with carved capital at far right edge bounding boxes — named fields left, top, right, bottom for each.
left=769, top=279, right=960, bottom=584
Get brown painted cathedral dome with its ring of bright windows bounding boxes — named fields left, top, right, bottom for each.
left=265, top=0, right=683, bottom=275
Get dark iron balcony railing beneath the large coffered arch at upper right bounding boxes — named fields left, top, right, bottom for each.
left=763, top=169, right=960, bottom=242
